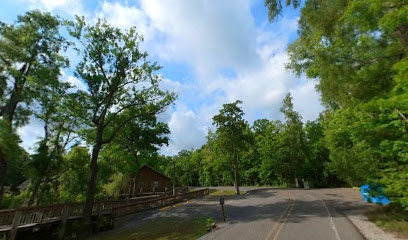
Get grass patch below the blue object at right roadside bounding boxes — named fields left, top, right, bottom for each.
left=366, top=205, right=408, bottom=237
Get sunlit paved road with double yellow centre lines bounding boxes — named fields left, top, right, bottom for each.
left=198, top=189, right=364, bottom=240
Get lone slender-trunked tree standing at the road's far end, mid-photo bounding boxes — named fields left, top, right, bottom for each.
left=213, top=100, right=248, bottom=195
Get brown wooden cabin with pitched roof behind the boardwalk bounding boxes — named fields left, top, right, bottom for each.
left=135, top=165, right=171, bottom=194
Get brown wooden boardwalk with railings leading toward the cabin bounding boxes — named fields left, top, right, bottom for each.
left=0, top=189, right=209, bottom=240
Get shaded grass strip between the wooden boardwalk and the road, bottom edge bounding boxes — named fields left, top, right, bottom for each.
left=99, top=216, right=215, bottom=240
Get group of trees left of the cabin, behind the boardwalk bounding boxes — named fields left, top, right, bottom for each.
left=0, top=11, right=177, bottom=236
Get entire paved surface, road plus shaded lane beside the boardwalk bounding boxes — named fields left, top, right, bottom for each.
left=94, top=187, right=367, bottom=240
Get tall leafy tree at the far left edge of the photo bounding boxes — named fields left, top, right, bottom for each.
left=0, top=11, right=68, bottom=205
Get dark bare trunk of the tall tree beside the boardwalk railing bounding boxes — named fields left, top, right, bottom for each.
left=81, top=141, right=102, bottom=239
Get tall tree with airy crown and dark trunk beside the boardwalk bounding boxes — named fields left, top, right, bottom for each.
left=69, top=18, right=176, bottom=236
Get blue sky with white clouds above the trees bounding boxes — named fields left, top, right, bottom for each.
left=0, top=0, right=323, bottom=155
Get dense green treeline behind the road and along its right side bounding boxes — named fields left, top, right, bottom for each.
left=163, top=0, right=408, bottom=209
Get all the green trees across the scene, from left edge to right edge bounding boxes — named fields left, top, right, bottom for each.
left=0, top=0, right=408, bottom=227
